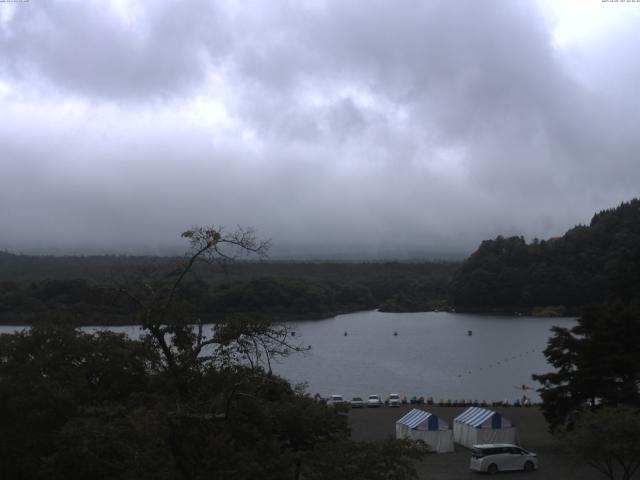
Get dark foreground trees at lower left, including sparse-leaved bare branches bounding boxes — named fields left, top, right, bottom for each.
left=0, top=227, right=420, bottom=480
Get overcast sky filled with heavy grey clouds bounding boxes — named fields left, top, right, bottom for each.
left=0, top=0, right=640, bottom=258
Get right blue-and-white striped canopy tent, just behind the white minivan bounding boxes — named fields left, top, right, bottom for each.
left=453, top=407, right=518, bottom=448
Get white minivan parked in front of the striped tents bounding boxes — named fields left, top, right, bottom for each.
left=469, top=443, right=538, bottom=474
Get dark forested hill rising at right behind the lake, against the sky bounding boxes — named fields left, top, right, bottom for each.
left=451, top=199, right=640, bottom=314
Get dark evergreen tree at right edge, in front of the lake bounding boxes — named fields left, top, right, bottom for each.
left=534, top=304, right=640, bottom=430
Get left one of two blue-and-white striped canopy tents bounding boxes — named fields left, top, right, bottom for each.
left=396, top=408, right=453, bottom=453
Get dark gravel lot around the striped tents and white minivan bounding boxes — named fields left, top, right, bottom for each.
left=349, top=405, right=605, bottom=480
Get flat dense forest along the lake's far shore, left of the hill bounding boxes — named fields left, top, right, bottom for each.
left=0, top=253, right=458, bottom=325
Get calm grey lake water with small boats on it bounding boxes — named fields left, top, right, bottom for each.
left=0, top=311, right=575, bottom=401
